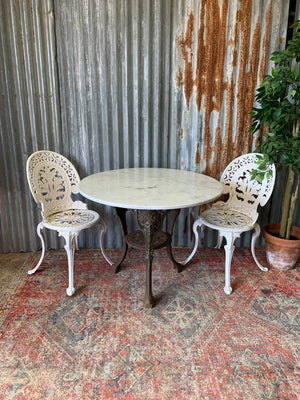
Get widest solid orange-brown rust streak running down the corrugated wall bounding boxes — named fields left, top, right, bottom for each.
left=195, top=0, right=228, bottom=176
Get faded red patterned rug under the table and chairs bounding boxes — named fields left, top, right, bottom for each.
left=0, top=248, right=300, bottom=400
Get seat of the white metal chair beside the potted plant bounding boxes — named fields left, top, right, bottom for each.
left=200, top=207, right=254, bottom=232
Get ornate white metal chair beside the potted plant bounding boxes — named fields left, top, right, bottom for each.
left=182, top=153, right=276, bottom=294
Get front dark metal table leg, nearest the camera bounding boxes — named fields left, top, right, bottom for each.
left=132, top=210, right=165, bottom=308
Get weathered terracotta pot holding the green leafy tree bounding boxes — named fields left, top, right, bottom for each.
left=263, top=224, right=300, bottom=271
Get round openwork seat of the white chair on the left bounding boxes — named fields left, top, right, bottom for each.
left=44, top=209, right=99, bottom=231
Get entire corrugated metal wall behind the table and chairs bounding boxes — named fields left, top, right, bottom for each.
left=0, top=0, right=300, bottom=252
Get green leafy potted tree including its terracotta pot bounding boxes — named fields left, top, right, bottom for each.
left=251, top=21, right=300, bottom=269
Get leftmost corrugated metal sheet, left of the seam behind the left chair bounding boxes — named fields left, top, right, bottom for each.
left=0, top=0, right=63, bottom=252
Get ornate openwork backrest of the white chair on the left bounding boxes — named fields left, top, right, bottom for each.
left=26, top=150, right=80, bottom=219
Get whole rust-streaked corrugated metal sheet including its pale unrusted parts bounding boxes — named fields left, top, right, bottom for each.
left=170, top=0, right=289, bottom=245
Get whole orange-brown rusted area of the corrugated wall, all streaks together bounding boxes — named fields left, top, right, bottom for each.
left=176, top=0, right=283, bottom=181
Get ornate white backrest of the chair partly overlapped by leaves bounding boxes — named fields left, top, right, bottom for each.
left=220, top=153, right=276, bottom=222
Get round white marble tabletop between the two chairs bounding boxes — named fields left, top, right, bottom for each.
left=79, top=168, right=223, bottom=210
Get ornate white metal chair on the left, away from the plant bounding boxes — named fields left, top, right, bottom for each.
left=26, top=150, right=106, bottom=296
